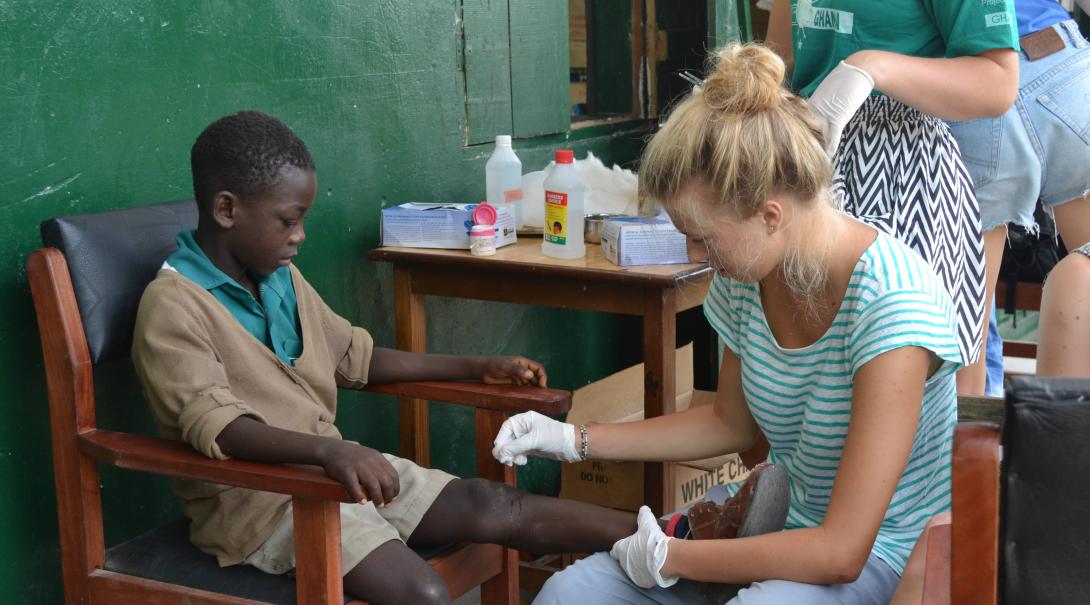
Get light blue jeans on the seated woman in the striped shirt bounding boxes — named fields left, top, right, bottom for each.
left=534, top=553, right=900, bottom=605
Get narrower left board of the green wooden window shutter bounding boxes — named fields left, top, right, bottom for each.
left=462, top=0, right=510, bottom=145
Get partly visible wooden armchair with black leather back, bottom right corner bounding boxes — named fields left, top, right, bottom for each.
left=923, top=376, right=1090, bottom=605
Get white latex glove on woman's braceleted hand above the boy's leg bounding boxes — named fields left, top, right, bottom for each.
left=492, top=412, right=581, bottom=467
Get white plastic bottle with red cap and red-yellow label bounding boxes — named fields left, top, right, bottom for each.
left=542, top=149, right=586, bottom=258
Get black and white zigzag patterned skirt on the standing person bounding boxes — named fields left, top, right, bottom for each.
left=833, top=96, right=984, bottom=364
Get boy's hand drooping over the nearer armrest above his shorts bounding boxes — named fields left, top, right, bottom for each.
left=320, top=440, right=401, bottom=507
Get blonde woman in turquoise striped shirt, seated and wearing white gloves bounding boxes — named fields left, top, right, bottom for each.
left=494, top=46, right=961, bottom=605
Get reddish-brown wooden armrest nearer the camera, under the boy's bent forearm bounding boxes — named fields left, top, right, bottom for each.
left=78, top=429, right=353, bottom=503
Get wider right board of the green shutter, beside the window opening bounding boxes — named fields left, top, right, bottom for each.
left=510, top=0, right=571, bottom=137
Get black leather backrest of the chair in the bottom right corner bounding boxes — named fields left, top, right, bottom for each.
left=1000, top=377, right=1090, bottom=604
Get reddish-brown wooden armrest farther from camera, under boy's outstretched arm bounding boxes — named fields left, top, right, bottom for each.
left=363, top=382, right=571, bottom=416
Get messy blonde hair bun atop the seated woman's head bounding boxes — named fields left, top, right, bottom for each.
left=703, top=44, right=790, bottom=114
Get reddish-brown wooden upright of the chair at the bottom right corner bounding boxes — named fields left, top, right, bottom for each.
left=950, top=422, right=1000, bottom=605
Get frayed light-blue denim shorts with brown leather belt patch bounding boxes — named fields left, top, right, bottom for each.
left=949, top=21, right=1090, bottom=231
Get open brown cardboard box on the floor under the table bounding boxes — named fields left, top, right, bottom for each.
left=560, top=344, right=749, bottom=515
